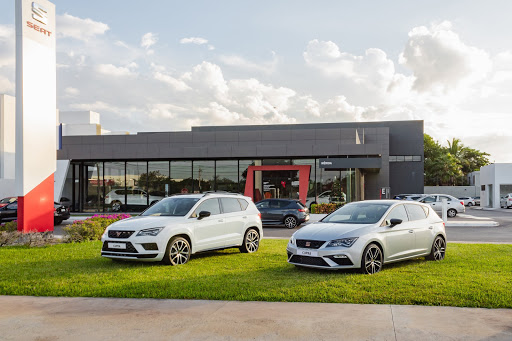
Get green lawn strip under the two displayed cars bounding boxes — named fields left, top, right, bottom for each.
left=0, top=240, right=512, bottom=308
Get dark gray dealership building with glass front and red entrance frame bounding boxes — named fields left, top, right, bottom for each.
left=55, top=121, right=424, bottom=212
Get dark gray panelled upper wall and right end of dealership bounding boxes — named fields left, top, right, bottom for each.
left=57, top=121, right=423, bottom=199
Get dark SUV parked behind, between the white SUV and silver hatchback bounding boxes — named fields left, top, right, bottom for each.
left=256, top=199, right=309, bottom=229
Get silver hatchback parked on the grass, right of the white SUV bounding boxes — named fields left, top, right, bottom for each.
left=286, top=200, right=446, bottom=274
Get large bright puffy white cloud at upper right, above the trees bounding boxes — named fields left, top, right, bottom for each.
left=400, top=21, right=492, bottom=92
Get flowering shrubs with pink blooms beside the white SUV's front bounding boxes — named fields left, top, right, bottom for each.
left=64, top=214, right=131, bottom=243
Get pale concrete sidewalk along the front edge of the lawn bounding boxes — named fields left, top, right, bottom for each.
left=0, top=296, right=512, bottom=341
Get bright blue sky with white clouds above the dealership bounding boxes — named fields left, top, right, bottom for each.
left=0, top=0, right=512, bottom=162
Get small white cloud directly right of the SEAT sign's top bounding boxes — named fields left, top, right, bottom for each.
left=56, top=13, right=109, bottom=41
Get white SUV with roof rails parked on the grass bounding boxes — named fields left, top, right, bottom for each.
left=101, top=193, right=263, bottom=265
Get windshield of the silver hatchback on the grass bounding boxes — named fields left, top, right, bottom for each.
left=322, top=202, right=391, bottom=224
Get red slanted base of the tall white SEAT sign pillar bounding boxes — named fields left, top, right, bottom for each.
left=18, top=174, right=54, bottom=233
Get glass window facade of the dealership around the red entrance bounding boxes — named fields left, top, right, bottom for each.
left=63, top=159, right=364, bottom=212
